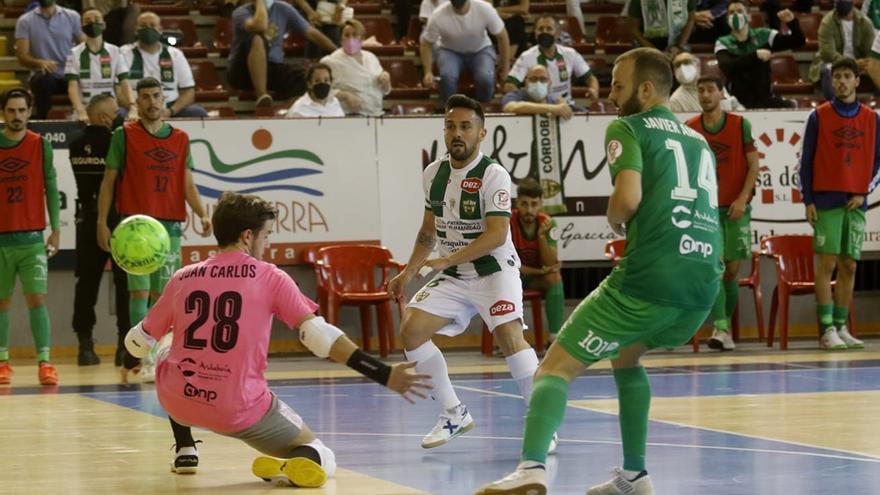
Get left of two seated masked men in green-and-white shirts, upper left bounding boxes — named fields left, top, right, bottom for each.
left=64, top=9, right=134, bottom=122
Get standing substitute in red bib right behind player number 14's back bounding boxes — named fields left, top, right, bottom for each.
left=687, top=76, right=758, bottom=351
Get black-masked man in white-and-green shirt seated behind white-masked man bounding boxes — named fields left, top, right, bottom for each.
left=504, top=15, right=599, bottom=111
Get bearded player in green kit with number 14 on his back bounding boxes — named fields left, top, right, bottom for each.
left=476, top=48, right=722, bottom=495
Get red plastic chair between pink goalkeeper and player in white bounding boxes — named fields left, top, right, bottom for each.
left=315, top=244, right=404, bottom=357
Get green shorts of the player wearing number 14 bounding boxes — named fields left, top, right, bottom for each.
left=557, top=279, right=711, bottom=365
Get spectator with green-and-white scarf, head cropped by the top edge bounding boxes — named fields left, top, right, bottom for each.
left=627, top=0, right=696, bottom=58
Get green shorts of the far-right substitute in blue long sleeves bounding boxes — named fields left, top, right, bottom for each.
left=813, top=206, right=865, bottom=260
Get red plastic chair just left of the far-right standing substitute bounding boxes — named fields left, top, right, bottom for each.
left=761, top=235, right=856, bottom=351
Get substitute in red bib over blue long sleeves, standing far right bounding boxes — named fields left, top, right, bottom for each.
left=800, top=57, right=880, bottom=350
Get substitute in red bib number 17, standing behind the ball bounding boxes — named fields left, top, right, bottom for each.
left=98, top=77, right=211, bottom=380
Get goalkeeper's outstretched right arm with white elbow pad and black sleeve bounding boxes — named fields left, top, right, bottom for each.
left=299, top=314, right=432, bottom=403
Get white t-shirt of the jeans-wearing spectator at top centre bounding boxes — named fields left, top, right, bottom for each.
left=422, top=0, right=504, bottom=53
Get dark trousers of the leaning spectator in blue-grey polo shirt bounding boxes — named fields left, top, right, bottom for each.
left=226, top=36, right=306, bottom=99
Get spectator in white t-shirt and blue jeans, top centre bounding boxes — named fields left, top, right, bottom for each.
left=420, top=0, right=510, bottom=106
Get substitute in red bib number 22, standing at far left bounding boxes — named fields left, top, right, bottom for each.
left=0, top=88, right=61, bottom=385
